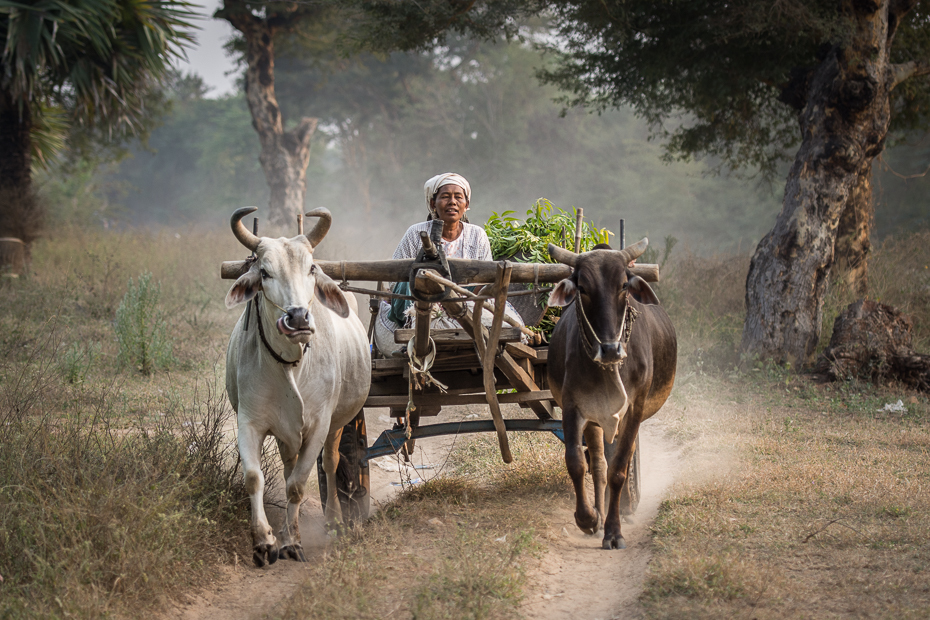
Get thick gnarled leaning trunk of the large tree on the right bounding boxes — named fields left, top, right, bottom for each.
left=742, top=0, right=910, bottom=366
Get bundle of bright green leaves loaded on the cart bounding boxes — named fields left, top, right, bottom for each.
left=484, top=198, right=613, bottom=340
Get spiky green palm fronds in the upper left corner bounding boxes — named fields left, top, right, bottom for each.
left=0, top=0, right=195, bottom=138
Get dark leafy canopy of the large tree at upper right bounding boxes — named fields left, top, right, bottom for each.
left=541, top=0, right=930, bottom=175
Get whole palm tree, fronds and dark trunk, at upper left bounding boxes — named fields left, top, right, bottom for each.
left=0, top=0, right=193, bottom=242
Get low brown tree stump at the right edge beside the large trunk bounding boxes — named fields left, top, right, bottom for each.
left=814, top=299, right=930, bottom=392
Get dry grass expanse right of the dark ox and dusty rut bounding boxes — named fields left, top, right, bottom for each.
left=644, top=372, right=930, bottom=618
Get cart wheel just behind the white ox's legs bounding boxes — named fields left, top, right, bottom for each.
left=316, top=409, right=371, bottom=527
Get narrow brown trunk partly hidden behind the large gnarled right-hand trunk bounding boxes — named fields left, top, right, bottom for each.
left=834, top=167, right=875, bottom=297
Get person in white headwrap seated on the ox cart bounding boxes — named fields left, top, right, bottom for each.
left=374, top=172, right=522, bottom=357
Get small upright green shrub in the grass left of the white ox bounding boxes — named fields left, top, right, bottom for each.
left=114, top=273, right=174, bottom=375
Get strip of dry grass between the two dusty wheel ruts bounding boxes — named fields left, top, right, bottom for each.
left=276, top=434, right=570, bottom=619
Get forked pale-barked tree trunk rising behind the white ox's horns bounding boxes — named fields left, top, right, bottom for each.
left=217, top=7, right=317, bottom=228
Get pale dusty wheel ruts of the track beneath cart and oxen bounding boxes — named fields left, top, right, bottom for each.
left=165, top=407, right=678, bottom=620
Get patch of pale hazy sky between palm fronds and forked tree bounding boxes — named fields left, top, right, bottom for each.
left=177, top=0, right=238, bottom=98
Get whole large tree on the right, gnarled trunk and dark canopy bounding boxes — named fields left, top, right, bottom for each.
left=543, top=0, right=930, bottom=364
